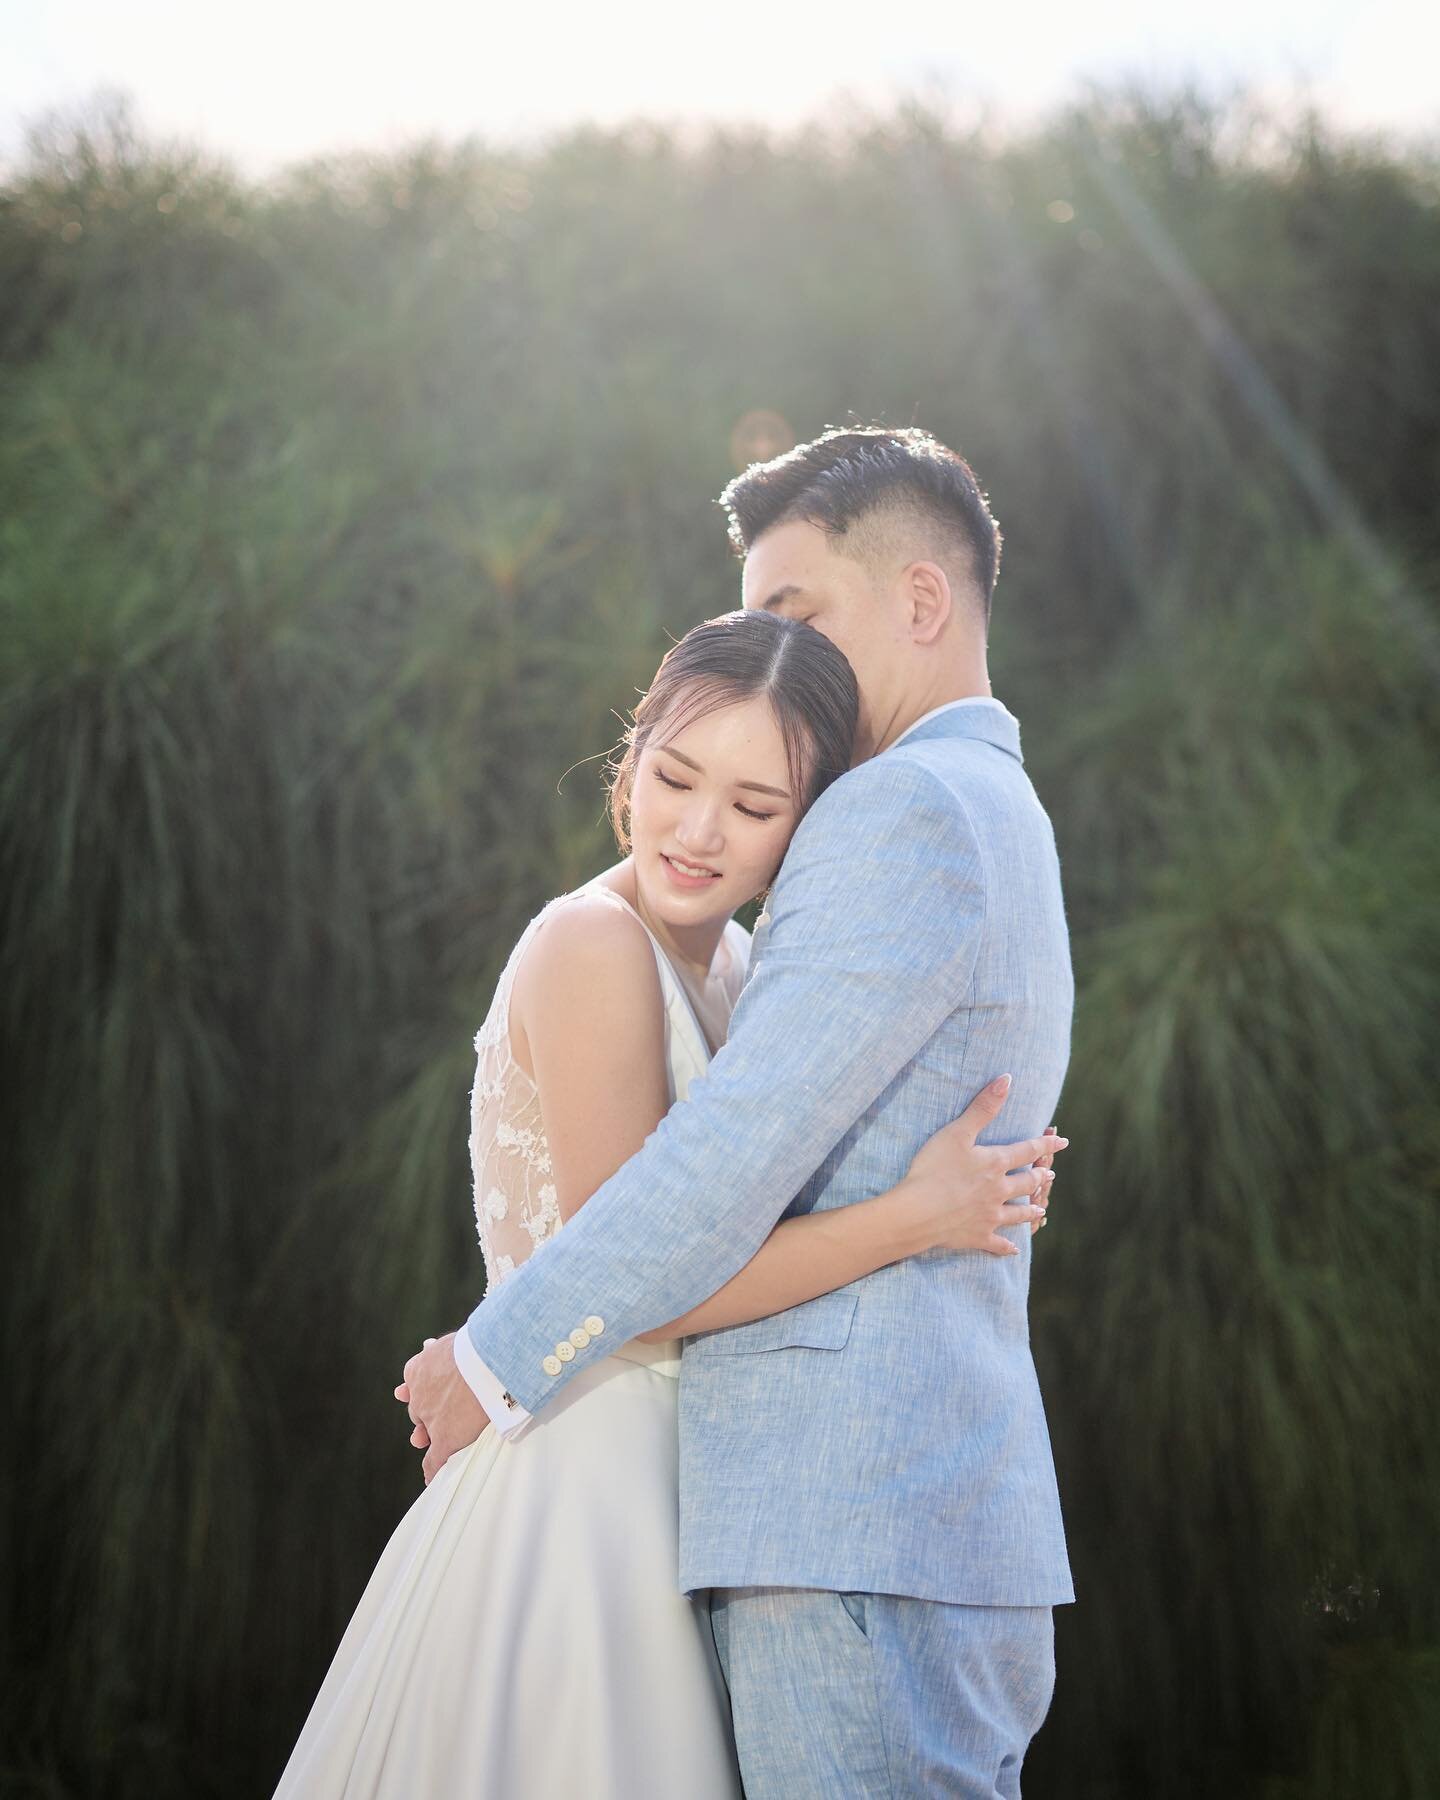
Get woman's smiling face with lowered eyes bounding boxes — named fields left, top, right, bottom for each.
left=630, top=698, right=799, bottom=927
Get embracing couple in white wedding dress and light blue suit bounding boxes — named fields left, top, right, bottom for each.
left=279, top=428, right=1073, bottom=1800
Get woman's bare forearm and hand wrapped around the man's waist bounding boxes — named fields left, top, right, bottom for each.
left=641, top=1084, right=1069, bottom=1343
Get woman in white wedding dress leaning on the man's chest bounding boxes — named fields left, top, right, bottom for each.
left=277, top=612, right=1051, bottom=1800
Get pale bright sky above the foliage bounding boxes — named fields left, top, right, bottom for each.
left=0, top=0, right=1440, bottom=173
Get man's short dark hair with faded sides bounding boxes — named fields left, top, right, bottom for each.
left=720, top=425, right=1001, bottom=619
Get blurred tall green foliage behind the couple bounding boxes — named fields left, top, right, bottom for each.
left=0, top=94, right=1440, bottom=1800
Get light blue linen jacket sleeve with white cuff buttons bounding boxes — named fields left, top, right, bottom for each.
left=466, top=749, right=986, bottom=1413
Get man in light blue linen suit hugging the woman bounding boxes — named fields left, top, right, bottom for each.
left=401, top=428, right=1073, bottom=1800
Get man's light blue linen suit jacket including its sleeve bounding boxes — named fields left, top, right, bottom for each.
left=468, top=706, right=1073, bottom=1606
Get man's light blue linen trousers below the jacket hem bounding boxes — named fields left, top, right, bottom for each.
left=711, top=1588, right=1055, bottom=1800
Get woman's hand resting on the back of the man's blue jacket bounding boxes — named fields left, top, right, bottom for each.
left=898, top=1076, right=1069, bottom=1256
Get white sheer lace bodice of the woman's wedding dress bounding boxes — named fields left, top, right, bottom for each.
left=470, top=882, right=749, bottom=1285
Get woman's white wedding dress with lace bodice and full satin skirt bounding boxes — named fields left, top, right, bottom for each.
left=275, top=884, right=749, bottom=1800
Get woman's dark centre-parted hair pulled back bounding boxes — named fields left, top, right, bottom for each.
left=610, top=612, right=860, bottom=851
